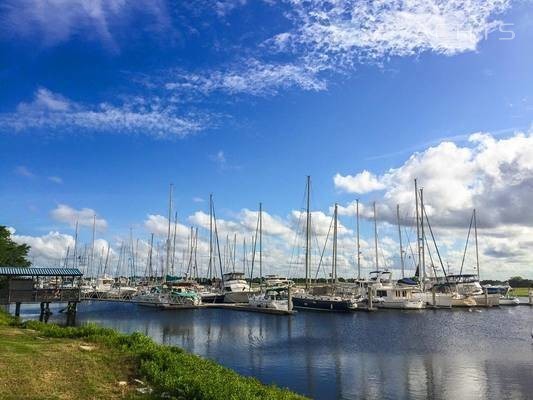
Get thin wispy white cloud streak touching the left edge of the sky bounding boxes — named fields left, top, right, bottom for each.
left=0, top=88, right=206, bottom=138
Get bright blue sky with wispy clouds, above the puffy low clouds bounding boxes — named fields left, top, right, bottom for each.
left=0, top=0, right=533, bottom=280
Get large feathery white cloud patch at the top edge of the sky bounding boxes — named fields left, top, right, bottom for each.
left=283, top=0, right=510, bottom=67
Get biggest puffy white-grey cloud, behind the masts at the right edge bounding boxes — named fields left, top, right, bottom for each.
left=339, top=133, right=533, bottom=278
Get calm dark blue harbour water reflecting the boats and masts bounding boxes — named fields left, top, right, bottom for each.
left=15, top=303, right=533, bottom=400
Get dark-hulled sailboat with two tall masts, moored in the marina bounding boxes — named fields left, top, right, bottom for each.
left=292, top=176, right=357, bottom=311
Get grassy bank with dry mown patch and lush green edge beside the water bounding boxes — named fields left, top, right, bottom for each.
left=0, top=310, right=303, bottom=400
